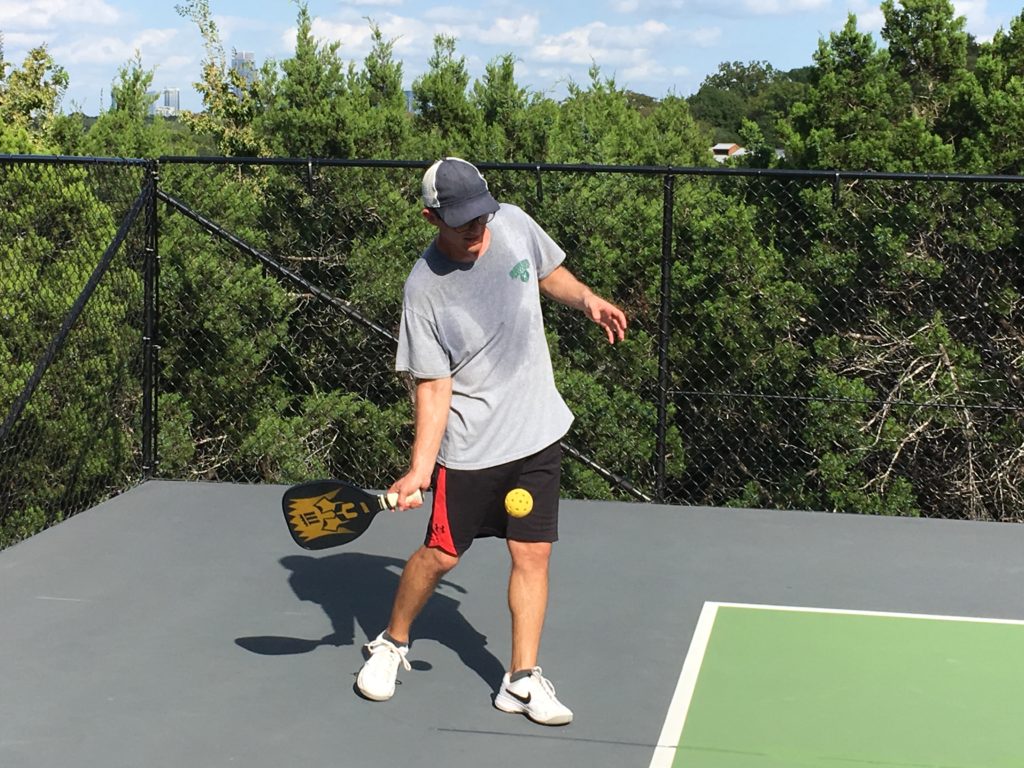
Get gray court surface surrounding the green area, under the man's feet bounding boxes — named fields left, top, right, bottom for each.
left=0, top=481, right=1024, bottom=768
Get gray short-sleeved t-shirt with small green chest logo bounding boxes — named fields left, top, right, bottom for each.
left=395, top=204, right=572, bottom=469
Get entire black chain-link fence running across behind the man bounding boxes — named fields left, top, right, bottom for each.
left=0, top=158, right=1024, bottom=537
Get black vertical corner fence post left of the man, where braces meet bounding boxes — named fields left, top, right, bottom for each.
left=142, top=161, right=160, bottom=480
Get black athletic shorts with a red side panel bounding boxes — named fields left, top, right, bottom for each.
left=424, top=442, right=562, bottom=557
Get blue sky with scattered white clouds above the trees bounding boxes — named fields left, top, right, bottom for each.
left=0, top=0, right=1022, bottom=115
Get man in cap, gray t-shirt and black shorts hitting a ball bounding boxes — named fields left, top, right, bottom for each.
left=356, top=158, right=626, bottom=725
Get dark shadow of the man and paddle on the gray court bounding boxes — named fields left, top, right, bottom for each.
left=234, top=552, right=505, bottom=693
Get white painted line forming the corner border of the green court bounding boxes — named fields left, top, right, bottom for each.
left=649, top=601, right=1024, bottom=768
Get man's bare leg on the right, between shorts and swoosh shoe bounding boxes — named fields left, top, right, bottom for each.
left=508, top=541, right=551, bottom=673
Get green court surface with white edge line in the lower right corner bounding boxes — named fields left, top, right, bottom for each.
left=651, top=603, right=1024, bottom=768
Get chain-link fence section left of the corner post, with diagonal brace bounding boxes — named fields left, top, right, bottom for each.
left=0, top=158, right=155, bottom=546
